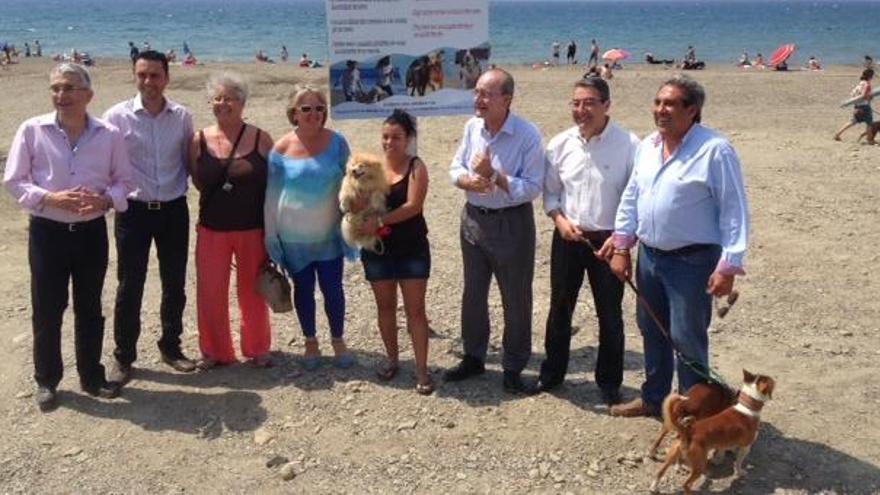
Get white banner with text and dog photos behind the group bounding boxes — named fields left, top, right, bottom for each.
left=326, top=0, right=491, bottom=120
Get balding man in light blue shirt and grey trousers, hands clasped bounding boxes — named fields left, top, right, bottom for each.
left=444, top=69, right=544, bottom=393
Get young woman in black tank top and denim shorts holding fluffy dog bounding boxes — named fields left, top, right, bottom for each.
left=361, top=110, right=434, bottom=395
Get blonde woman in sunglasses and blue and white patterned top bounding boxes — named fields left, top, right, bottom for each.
left=265, top=86, right=356, bottom=369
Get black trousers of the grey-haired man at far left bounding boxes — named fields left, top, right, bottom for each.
left=28, top=217, right=108, bottom=390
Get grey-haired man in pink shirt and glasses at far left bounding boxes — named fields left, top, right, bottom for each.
left=3, top=63, right=131, bottom=411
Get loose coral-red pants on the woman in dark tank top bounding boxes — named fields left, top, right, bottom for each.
left=196, top=226, right=272, bottom=364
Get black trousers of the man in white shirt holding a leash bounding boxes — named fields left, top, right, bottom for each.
left=541, top=230, right=624, bottom=391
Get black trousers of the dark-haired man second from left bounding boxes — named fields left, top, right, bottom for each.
left=113, top=196, right=189, bottom=365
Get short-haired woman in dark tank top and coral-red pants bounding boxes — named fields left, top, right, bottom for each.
left=190, top=73, right=272, bottom=369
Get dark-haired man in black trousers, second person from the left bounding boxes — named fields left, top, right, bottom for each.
left=104, top=50, right=195, bottom=385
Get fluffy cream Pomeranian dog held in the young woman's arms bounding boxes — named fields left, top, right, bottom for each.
left=339, top=153, right=389, bottom=254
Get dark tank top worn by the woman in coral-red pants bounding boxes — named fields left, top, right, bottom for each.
left=197, top=129, right=267, bottom=231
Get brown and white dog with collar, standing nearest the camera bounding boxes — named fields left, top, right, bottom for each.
left=651, top=370, right=776, bottom=494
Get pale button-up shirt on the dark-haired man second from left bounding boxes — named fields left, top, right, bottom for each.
left=104, top=95, right=193, bottom=201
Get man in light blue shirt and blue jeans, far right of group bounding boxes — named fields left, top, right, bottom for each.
left=601, top=76, right=749, bottom=416
